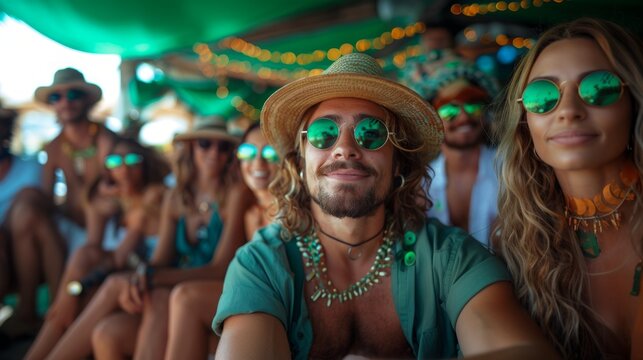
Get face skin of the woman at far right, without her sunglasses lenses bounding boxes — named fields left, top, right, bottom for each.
left=526, top=38, right=633, bottom=172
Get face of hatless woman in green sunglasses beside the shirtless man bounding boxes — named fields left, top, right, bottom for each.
left=105, top=143, right=144, bottom=189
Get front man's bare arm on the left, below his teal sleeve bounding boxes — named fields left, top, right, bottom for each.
left=215, top=313, right=291, bottom=360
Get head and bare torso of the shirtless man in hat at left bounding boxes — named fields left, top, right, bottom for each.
left=34, top=68, right=115, bottom=226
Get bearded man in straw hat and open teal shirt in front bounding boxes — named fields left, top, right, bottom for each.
left=213, top=54, right=555, bottom=359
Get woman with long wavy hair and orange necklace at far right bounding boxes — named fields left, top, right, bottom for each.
left=495, top=19, right=643, bottom=359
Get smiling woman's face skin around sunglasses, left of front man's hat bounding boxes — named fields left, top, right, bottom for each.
left=240, top=128, right=278, bottom=192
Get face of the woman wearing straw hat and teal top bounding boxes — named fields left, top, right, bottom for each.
left=192, top=138, right=234, bottom=178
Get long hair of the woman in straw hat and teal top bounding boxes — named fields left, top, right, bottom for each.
left=172, top=136, right=238, bottom=213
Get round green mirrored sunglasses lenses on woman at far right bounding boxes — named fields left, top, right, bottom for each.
left=517, top=70, right=627, bottom=114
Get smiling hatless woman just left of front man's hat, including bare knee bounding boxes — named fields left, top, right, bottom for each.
left=165, top=123, right=279, bottom=359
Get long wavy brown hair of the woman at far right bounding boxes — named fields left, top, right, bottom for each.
left=494, top=18, right=643, bottom=359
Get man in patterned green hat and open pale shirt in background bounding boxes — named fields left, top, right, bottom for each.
left=402, top=50, right=498, bottom=246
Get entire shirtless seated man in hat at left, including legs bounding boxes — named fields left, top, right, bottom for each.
left=7, top=68, right=121, bottom=305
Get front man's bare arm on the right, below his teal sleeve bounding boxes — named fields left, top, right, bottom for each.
left=456, top=282, right=559, bottom=359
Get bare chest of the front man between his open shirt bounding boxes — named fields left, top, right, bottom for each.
left=306, top=277, right=413, bottom=359
